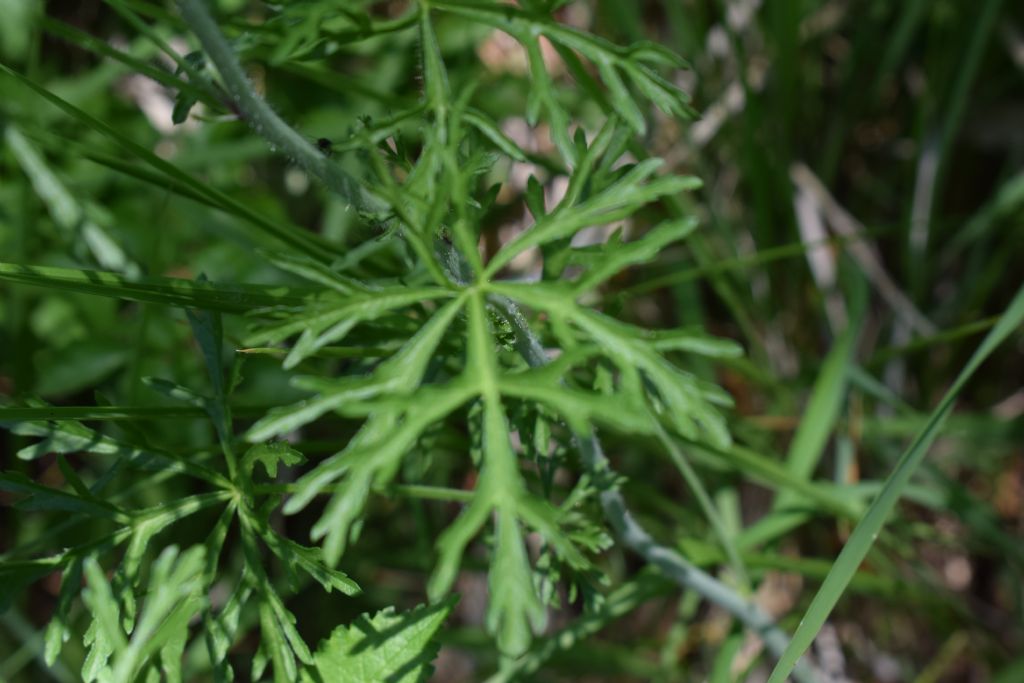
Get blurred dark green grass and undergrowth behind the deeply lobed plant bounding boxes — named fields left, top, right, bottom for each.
left=0, top=0, right=1024, bottom=681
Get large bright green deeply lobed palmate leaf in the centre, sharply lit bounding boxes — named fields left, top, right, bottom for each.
left=240, top=76, right=724, bottom=666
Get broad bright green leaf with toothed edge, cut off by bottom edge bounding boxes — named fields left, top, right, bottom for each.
left=302, top=597, right=458, bottom=683
